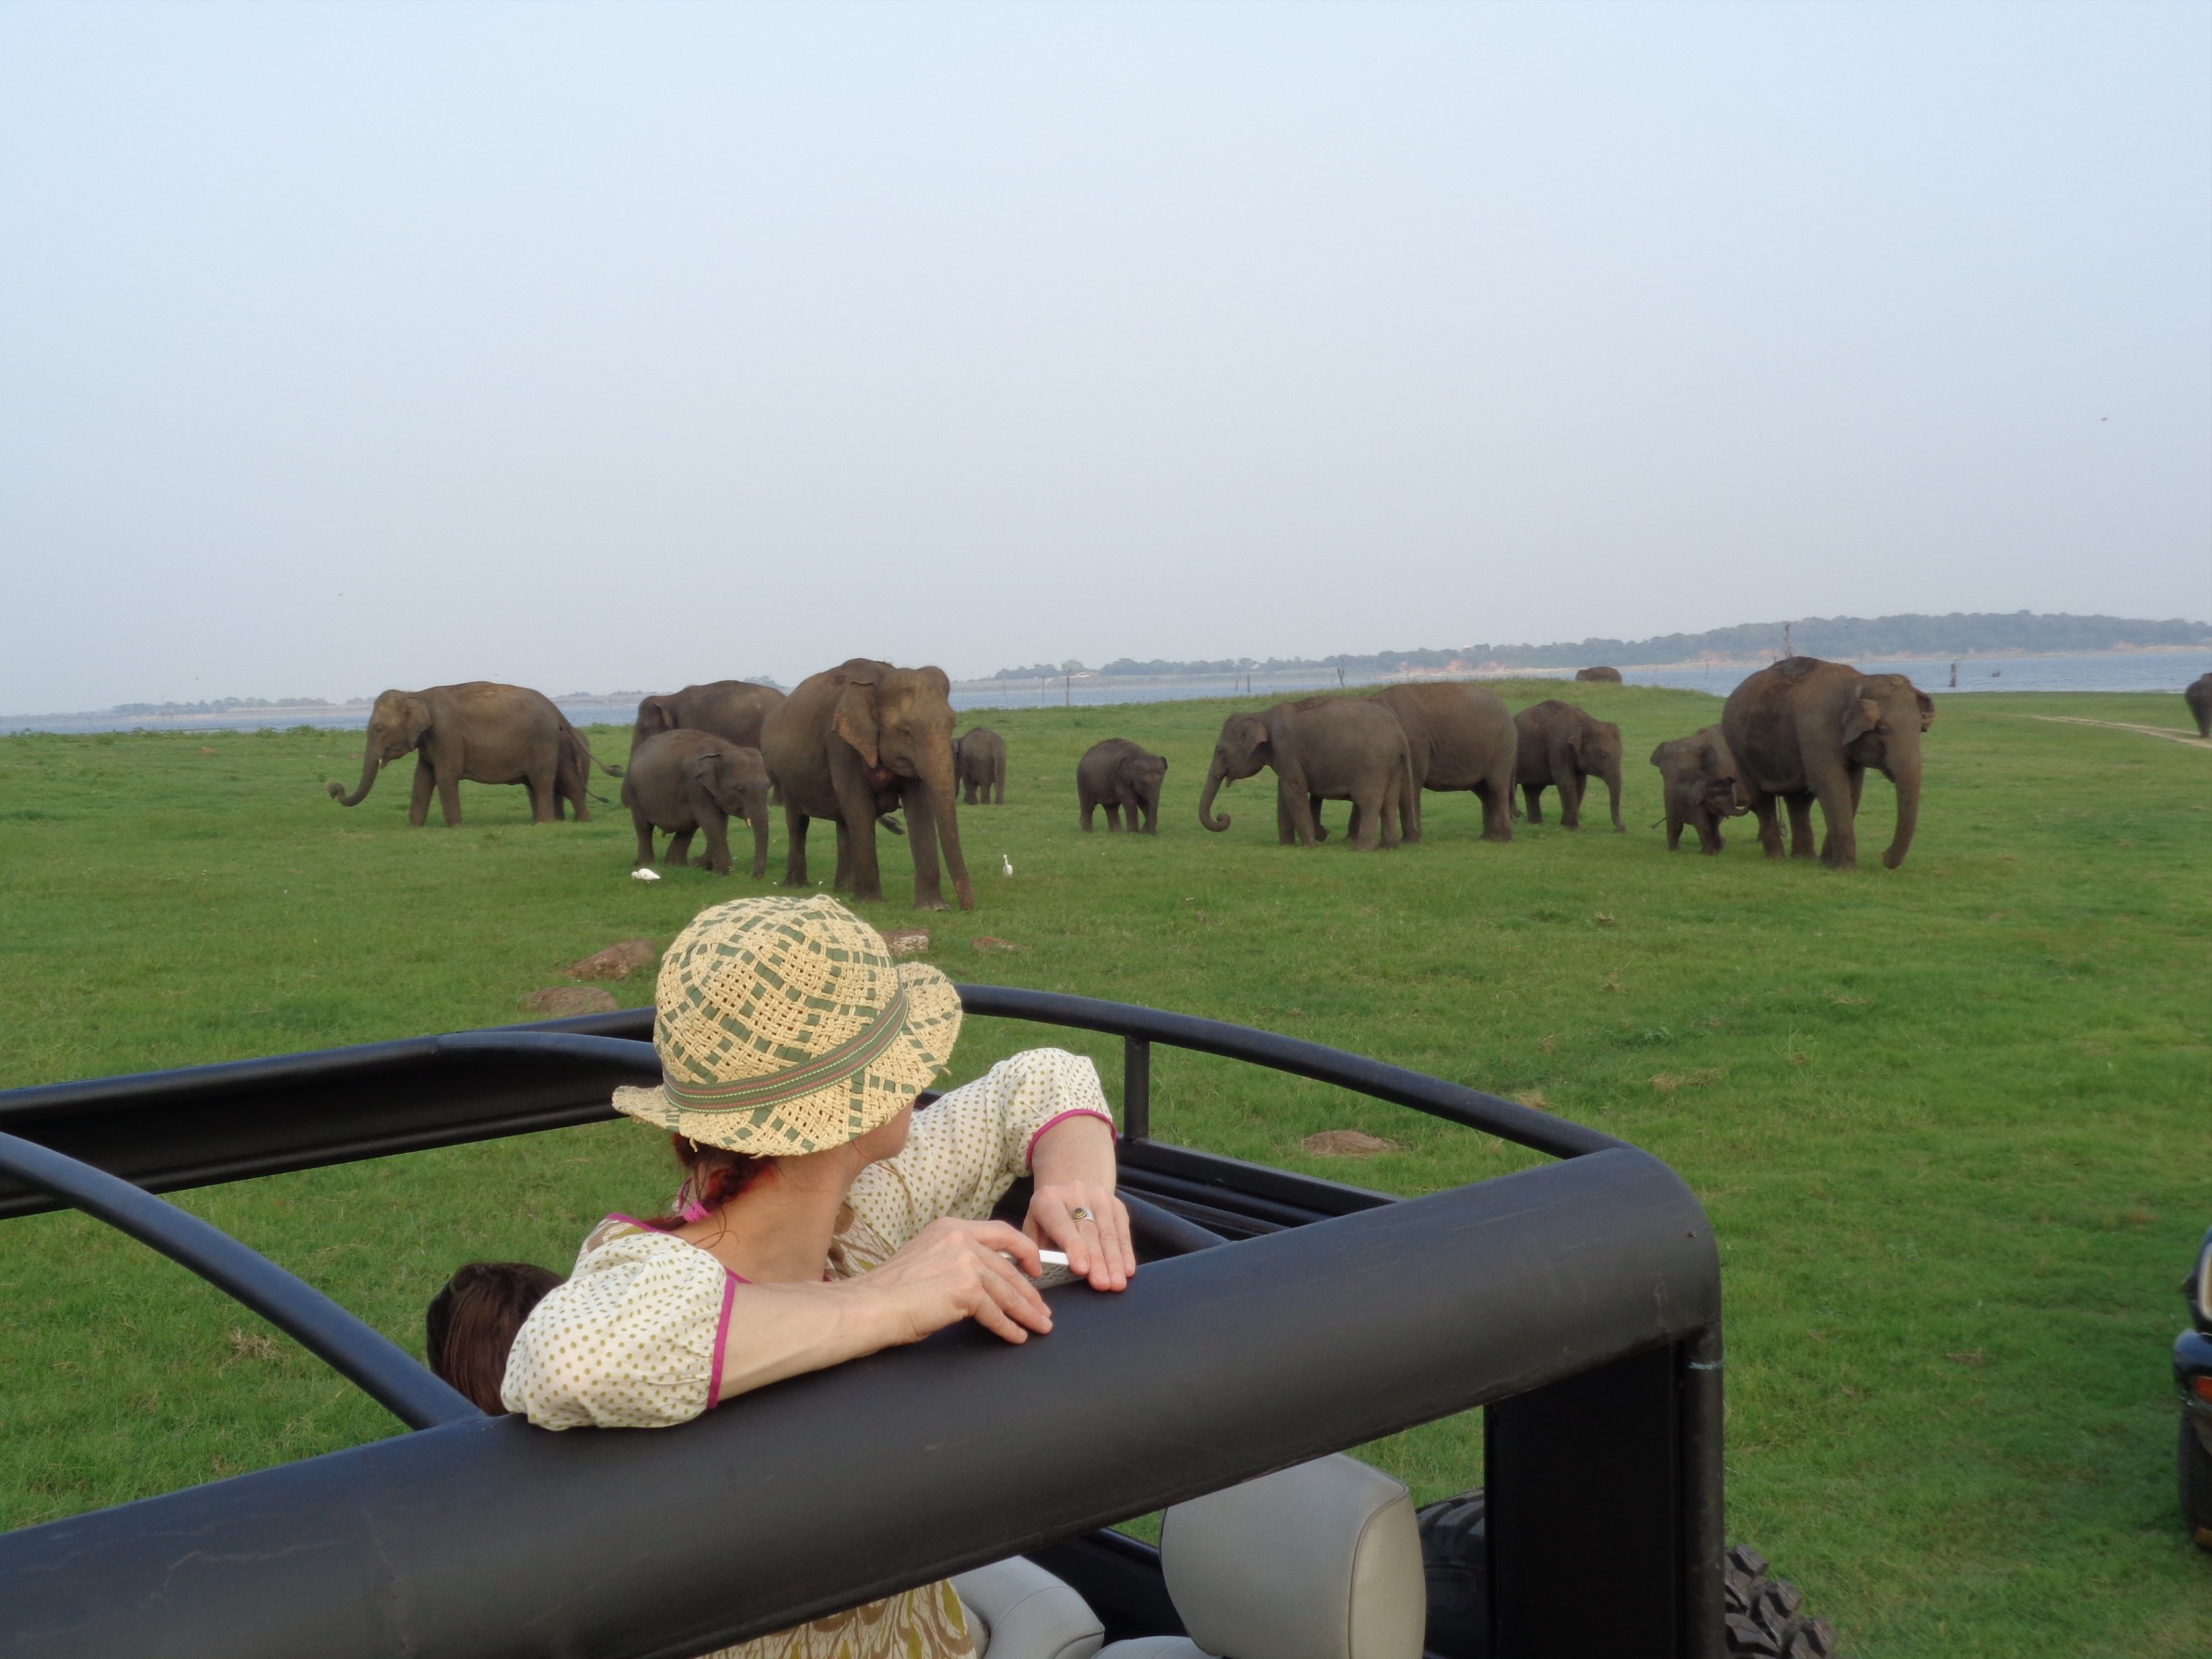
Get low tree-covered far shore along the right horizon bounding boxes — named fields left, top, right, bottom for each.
left=991, top=610, right=2212, bottom=679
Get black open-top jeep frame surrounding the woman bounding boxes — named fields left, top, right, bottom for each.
left=0, top=984, right=1724, bottom=1659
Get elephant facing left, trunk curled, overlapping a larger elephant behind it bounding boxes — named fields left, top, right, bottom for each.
left=1199, top=697, right=1420, bottom=852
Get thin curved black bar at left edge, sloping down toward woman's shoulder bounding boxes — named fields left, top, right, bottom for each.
left=0, top=1135, right=485, bottom=1429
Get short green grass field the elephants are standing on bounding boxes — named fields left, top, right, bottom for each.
left=0, top=681, right=2212, bottom=1659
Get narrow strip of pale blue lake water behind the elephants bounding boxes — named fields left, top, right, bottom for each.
left=0, top=651, right=2212, bottom=734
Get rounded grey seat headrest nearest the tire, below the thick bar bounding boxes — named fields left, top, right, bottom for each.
left=1100, top=1455, right=1429, bottom=1659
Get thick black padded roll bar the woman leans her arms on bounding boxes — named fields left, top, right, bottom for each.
left=0, top=1148, right=1719, bottom=1659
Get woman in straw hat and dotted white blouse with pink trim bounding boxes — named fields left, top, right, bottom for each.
left=502, top=894, right=1137, bottom=1659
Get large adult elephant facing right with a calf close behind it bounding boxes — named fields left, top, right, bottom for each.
left=1721, top=657, right=1936, bottom=869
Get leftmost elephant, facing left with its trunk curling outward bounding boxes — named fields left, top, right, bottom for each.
left=330, top=679, right=621, bottom=828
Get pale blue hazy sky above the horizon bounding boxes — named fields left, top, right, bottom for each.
left=0, top=0, right=2212, bottom=710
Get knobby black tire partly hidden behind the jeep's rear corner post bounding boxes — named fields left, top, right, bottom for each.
left=1416, top=1495, right=1840, bottom=1659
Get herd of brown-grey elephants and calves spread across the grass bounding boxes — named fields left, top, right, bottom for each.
left=330, top=657, right=1936, bottom=909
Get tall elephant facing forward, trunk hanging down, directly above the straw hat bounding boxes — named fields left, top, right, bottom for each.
left=761, top=657, right=975, bottom=909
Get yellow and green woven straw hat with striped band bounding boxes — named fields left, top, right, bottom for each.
left=615, top=894, right=960, bottom=1157
